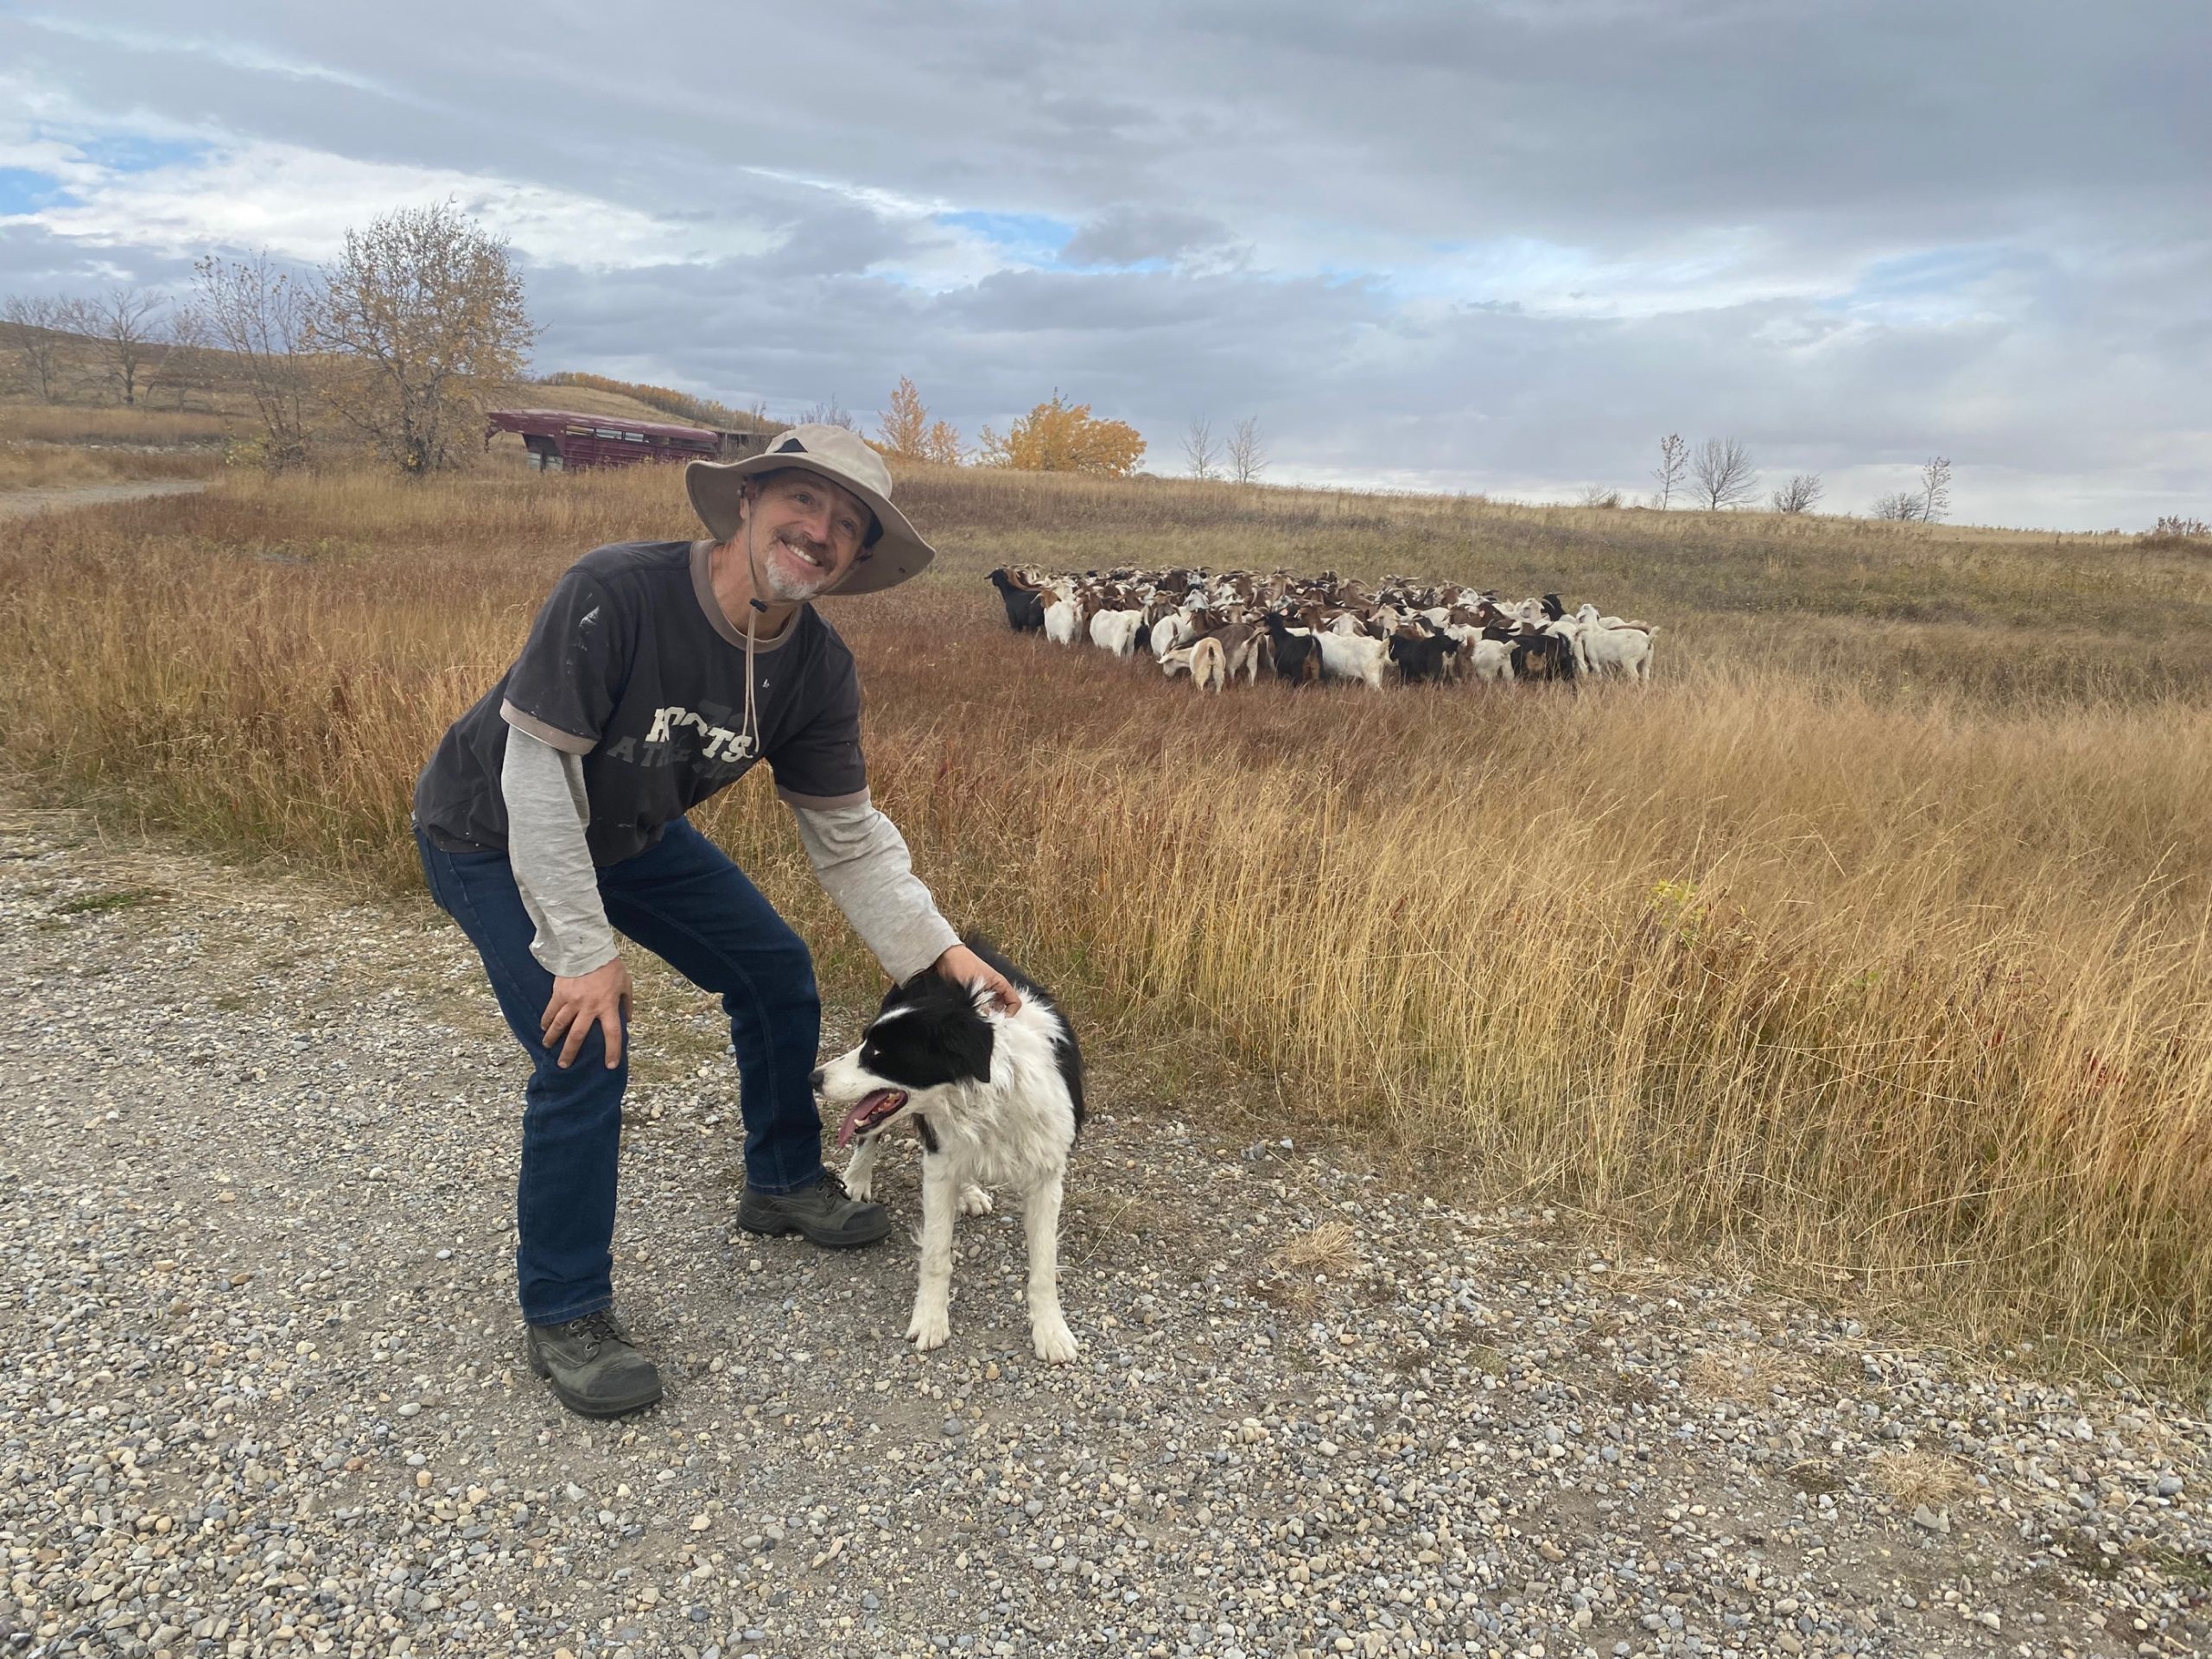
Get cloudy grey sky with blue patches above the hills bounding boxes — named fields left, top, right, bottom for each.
left=0, top=0, right=2212, bottom=529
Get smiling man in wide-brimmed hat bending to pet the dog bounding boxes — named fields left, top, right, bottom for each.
left=414, top=425, right=1020, bottom=1415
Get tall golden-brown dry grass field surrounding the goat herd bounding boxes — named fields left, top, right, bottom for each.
left=13, top=474, right=2212, bottom=1354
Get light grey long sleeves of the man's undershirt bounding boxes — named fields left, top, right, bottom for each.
left=500, top=728, right=960, bottom=980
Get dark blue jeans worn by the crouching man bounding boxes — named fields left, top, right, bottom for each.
left=416, top=818, right=823, bottom=1325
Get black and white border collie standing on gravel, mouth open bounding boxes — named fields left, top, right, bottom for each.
left=814, top=938, right=1084, bottom=1365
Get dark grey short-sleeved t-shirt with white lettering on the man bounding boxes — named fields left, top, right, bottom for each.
left=414, top=542, right=868, bottom=865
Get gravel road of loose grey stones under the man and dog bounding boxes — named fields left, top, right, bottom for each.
left=0, top=807, right=2212, bottom=1659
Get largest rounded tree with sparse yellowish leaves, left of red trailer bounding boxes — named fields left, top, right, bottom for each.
left=308, top=201, right=535, bottom=474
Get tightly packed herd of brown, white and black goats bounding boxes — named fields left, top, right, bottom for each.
left=991, top=569, right=1656, bottom=690
